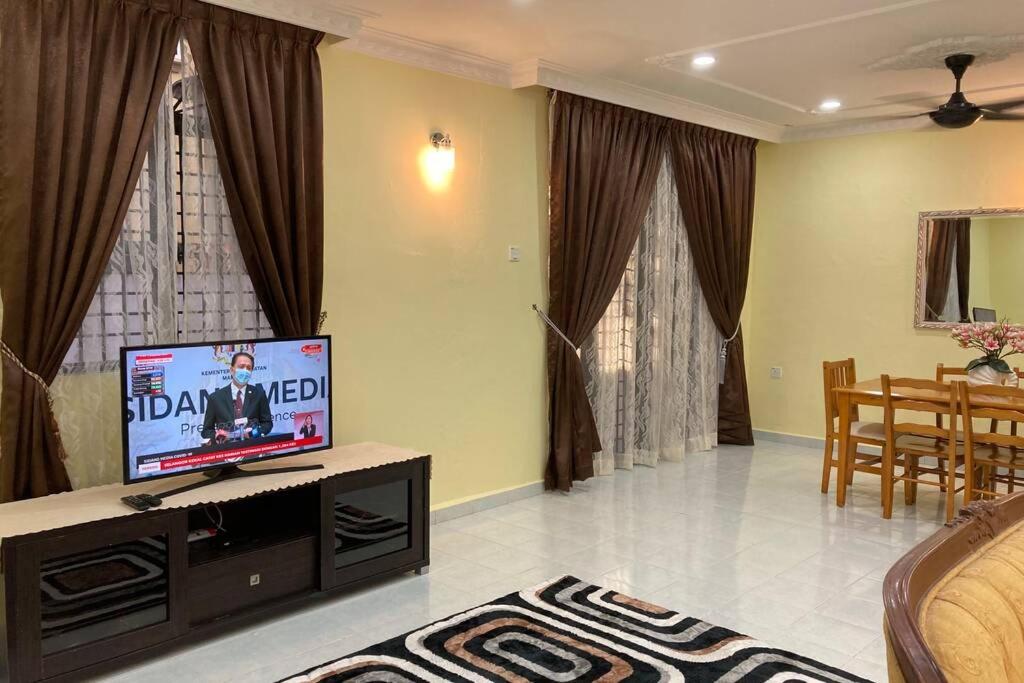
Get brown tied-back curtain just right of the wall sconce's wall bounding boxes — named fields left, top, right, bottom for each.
left=545, top=92, right=667, bottom=490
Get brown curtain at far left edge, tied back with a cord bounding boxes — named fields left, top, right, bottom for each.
left=0, top=0, right=180, bottom=502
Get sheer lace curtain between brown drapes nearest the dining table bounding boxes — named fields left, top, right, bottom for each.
left=581, top=155, right=722, bottom=474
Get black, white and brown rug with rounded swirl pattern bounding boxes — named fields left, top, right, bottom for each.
left=286, top=577, right=864, bottom=683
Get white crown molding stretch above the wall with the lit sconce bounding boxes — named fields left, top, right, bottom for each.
left=344, top=27, right=512, bottom=88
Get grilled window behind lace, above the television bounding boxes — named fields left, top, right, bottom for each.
left=62, top=41, right=273, bottom=373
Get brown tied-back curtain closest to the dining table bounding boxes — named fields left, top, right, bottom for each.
left=669, top=122, right=758, bottom=445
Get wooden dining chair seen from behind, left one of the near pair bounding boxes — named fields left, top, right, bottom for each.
left=882, top=375, right=965, bottom=521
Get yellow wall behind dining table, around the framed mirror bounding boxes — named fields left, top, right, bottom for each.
left=745, top=122, right=1024, bottom=436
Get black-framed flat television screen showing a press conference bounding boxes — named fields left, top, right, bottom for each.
left=121, top=337, right=331, bottom=483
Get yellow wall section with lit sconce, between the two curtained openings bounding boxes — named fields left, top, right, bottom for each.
left=321, top=45, right=547, bottom=505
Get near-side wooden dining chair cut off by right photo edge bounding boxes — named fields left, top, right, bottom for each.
left=961, top=383, right=1024, bottom=504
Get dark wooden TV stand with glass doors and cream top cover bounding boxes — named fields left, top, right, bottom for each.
left=0, top=443, right=430, bottom=683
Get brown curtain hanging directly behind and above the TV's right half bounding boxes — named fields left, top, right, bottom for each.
left=185, top=0, right=324, bottom=336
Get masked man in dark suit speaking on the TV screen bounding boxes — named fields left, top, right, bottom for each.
left=202, top=351, right=273, bottom=443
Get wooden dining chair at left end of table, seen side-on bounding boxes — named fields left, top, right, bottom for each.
left=821, top=358, right=885, bottom=494
